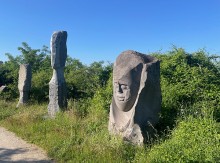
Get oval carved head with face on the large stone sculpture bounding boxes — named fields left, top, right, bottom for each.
left=113, top=50, right=144, bottom=112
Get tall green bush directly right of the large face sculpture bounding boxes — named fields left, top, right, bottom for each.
left=154, top=48, right=220, bottom=129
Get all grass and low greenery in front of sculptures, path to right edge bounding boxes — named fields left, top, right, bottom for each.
left=0, top=101, right=220, bottom=162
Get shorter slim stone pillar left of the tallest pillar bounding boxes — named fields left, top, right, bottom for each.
left=17, top=64, right=32, bottom=107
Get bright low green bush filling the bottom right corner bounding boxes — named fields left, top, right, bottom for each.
left=135, top=117, right=220, bottom=163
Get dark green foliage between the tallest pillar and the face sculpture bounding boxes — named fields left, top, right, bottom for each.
left=65, top=57, right=112, bottom=99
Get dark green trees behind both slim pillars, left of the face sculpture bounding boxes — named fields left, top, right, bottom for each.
left=0, top=42, right=112, bottom=102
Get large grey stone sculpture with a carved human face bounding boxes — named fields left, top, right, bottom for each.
left=108, top=50, right=161, bottom=145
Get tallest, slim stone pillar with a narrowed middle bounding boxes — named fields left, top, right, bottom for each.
left=48, top=31, right=67, bottom=117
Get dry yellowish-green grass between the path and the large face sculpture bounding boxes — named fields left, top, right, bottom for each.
left=1, top=101, right=139, bottom=162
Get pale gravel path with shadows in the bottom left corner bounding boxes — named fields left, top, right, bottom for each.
left=0, top=127, right=53, bottom=163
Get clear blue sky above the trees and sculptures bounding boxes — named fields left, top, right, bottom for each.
left=0, top=0, right=220, bottom=64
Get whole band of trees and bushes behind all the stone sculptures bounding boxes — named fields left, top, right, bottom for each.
left=0, top=43, right=220, bottom=123
